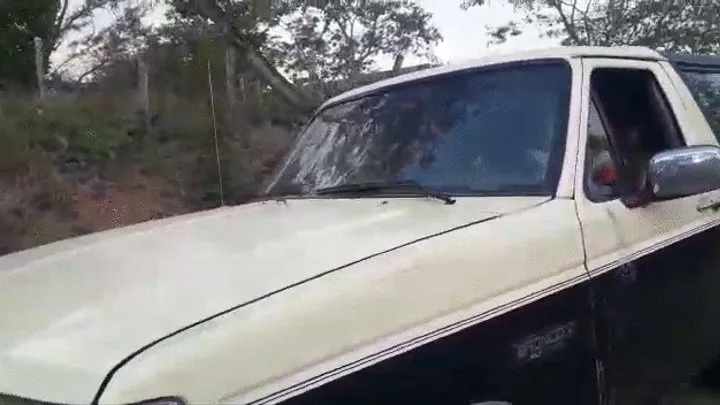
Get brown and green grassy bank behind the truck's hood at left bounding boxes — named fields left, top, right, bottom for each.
left=0, top=92, right=291, bottom=254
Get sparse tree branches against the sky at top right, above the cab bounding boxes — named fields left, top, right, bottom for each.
left=462, top=0, right=720, bottom=53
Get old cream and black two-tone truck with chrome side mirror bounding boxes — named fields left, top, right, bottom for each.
left=0, top=47, right=720, bottom=405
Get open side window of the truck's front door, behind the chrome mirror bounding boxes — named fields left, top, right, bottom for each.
left=584, top=68, right=685, bottom=202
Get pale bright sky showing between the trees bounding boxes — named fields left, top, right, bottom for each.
left=53, top=0, right=558, bottom=73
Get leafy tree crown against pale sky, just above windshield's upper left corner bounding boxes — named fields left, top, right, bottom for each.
left=270, top=0, right=442, bottom=96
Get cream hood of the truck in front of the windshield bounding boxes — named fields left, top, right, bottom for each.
left=0, top=197, right=547, bottom=404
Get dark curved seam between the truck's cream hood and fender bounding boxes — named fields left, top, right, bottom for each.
left=91, top=199, right=552, bottom=405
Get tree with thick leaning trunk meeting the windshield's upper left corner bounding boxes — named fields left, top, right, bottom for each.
left=163, top=0, right=439, bottom=113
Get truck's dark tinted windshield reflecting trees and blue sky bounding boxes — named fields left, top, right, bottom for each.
left=266, top=60, right=571, bottom=195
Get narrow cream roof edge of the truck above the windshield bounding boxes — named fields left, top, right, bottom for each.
left=321, top=46, right=667, bottom=108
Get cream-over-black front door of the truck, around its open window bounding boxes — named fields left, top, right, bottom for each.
left=575, top=58, right=720, bottom=405
